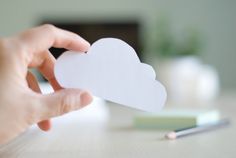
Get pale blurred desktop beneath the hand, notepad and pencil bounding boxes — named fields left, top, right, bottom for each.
left=0, top=92, right=236, bottom=158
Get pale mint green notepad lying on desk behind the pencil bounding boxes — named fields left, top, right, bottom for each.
left=134, top=109, right=220, bottom=130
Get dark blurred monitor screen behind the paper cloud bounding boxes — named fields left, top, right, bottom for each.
left=41, top=21, right=141, bottom=58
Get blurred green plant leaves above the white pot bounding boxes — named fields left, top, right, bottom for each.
left=154, top=18, right=203, bottom=57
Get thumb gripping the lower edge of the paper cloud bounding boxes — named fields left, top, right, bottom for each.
left=39, top=89, right=93, bottom=120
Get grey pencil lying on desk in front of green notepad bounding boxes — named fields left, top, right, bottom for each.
left=165, top=119, right=230, bottom=139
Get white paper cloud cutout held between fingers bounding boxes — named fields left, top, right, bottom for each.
left=54, top=38, right=166, bottom=112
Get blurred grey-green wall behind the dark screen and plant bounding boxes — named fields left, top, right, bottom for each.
left=0, top=0, right=236, bottom=89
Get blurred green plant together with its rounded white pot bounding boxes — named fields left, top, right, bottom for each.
left=153, top=19, right=219, bottom=104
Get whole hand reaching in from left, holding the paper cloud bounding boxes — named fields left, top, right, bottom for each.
left=0, top=24, right=92, bottom=144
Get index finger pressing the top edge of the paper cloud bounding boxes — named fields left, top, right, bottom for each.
left=19, top=24, right=90, bottom=60
